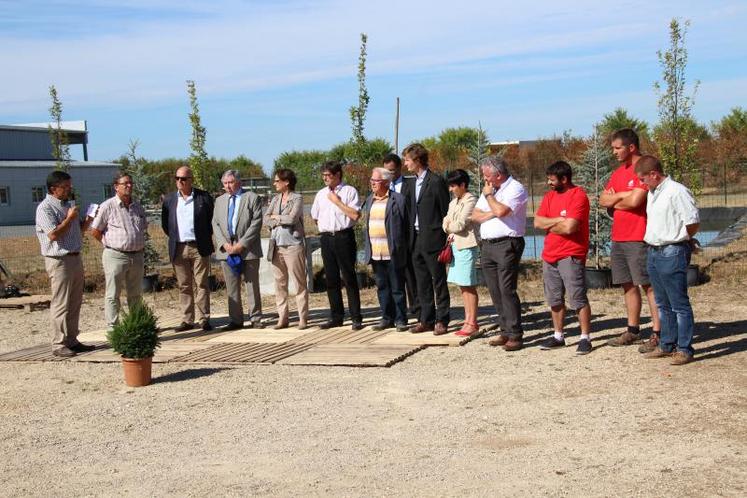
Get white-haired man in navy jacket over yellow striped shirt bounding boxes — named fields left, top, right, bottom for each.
left=363, top=168, right=408, bottom=332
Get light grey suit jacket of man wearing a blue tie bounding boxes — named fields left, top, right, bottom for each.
left=213, top=190, right=262, bottom=260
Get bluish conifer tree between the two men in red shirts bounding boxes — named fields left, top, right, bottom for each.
left=573, top=126, right=615, bottom=268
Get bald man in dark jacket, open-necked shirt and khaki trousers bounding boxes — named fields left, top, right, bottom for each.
left=161, top=166, right=214, bottom=332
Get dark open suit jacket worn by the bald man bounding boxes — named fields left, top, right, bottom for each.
left=161, top=188, right=215, bottom=263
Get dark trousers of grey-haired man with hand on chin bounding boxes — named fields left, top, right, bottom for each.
left=481, top=237, right=524, bottom=339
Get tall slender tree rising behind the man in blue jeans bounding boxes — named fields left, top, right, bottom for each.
left=654, top=19, right=702, bottom=195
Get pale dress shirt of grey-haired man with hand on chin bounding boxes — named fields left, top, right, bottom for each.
left=475, top=176, right=529, bottom=239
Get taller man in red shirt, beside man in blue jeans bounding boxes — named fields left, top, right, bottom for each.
left=599, top=128, right=661, bottom=353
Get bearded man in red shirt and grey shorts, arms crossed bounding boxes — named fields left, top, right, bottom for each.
left=534, top=161, right=592, bottom=354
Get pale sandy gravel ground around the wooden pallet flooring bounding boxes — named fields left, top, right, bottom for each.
left=0, top=281, right=747, bottom=496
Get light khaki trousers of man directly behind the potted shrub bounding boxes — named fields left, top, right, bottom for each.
left=101, top=248, right=145, bottom=328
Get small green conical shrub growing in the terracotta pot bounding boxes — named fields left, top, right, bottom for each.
left=107, top=301, right=161, bottom=360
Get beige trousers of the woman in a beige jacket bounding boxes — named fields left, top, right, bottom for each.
left=272, top=244, right=309, bottom=324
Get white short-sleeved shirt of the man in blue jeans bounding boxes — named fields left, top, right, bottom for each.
left=643, top=177, right=700, bottom=246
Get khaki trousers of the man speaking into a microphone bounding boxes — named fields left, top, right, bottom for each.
left=44, top=254, right=83, bottom=347
